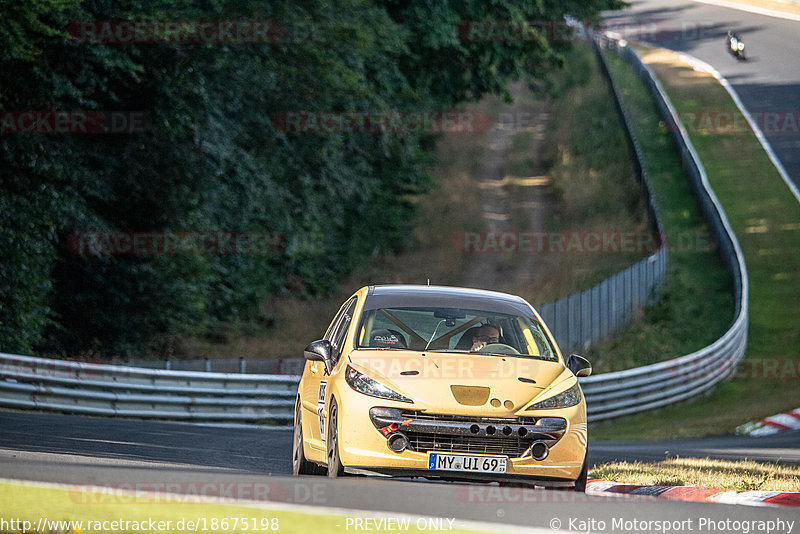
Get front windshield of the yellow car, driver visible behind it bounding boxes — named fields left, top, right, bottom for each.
left=356, top=307, right=557, bottom=361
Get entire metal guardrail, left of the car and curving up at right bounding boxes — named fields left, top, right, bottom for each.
left=0, top=33, right=748, bottom=427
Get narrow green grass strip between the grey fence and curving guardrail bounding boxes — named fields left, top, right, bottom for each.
left=586, top=51, right=734, bottom=376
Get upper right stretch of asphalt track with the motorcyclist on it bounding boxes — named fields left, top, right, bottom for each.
left=605, top=0, right=800, bottom=191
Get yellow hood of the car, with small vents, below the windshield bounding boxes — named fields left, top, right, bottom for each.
left=349, top=350, right=572, bottom=417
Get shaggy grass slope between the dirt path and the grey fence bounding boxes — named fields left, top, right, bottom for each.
left=523, top=46, right=650, bottom=306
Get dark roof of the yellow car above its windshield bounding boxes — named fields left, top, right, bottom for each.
left=365, top=284, right=531, bottom=316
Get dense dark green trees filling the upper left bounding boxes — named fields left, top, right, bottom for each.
left=0, top=0, right=620, bottom=360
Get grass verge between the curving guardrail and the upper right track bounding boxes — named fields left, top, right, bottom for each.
left=591, top=47, right=800, bottom=440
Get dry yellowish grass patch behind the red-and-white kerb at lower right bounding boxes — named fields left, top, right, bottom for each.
left=591, top=458, right=800, bottom=491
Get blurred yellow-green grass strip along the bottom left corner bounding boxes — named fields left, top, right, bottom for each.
left=0, top=481, right=490, bottom=534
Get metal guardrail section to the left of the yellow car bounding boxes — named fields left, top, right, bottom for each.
left=0, top=354, right=299, bottom=426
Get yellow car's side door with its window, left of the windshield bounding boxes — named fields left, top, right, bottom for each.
left=303, top=297, right=357, bottom=450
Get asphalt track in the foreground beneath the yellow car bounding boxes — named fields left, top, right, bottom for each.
left=0, top=412, right=800, bottom=532
